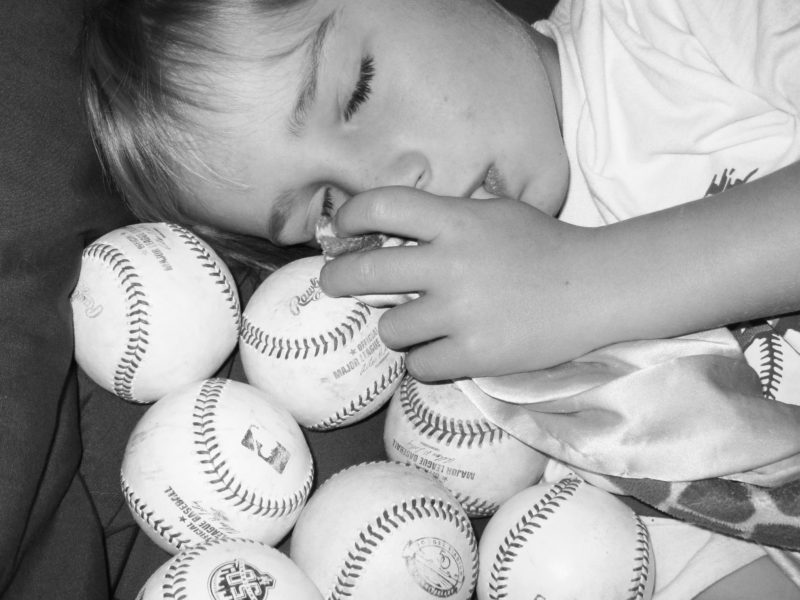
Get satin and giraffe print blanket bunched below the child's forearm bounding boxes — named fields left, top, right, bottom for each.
left=462, top=315, right=800, bottom=551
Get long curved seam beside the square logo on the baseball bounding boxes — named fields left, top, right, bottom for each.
left=192, top=379, right=314, bottom=517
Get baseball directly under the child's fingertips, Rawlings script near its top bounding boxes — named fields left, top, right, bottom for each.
left=239, top=256, right=405, bottom=430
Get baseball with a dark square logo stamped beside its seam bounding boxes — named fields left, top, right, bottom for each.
left=121, top=379, right=314, bottom=553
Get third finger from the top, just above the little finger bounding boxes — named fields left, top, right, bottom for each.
left=378, top=296, right=448, bottom=350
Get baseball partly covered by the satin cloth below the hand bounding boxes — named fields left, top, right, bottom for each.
left=383, top=375, right=549, bottom=517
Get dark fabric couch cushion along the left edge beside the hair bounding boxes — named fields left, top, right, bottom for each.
left=0, top=0, right=130, bottom=599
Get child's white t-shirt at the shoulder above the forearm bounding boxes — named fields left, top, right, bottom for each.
left=534, top=0, right=800, bottom=226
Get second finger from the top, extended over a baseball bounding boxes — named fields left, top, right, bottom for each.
left=320, top=246, right=430, bottom=298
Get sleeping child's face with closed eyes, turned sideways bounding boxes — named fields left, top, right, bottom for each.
left=188, top=0, right=569, bottom=245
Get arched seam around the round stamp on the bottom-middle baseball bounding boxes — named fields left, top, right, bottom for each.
left=328, top=497, right=478, bottom=600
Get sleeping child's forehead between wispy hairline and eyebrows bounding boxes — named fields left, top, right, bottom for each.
left=176, top=6, right=337, bottom=239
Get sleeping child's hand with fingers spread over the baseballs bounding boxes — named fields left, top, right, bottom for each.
left=321, top=187, right=600, bottom=381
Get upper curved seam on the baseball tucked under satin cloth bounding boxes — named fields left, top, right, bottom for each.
left=400, top=377, right=506, bottom=448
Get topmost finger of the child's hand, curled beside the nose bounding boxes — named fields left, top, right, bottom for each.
left=334, top=187, right=461, bottom=242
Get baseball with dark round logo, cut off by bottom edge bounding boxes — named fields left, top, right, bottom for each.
left=136, top=539, right=322, bottom=600
